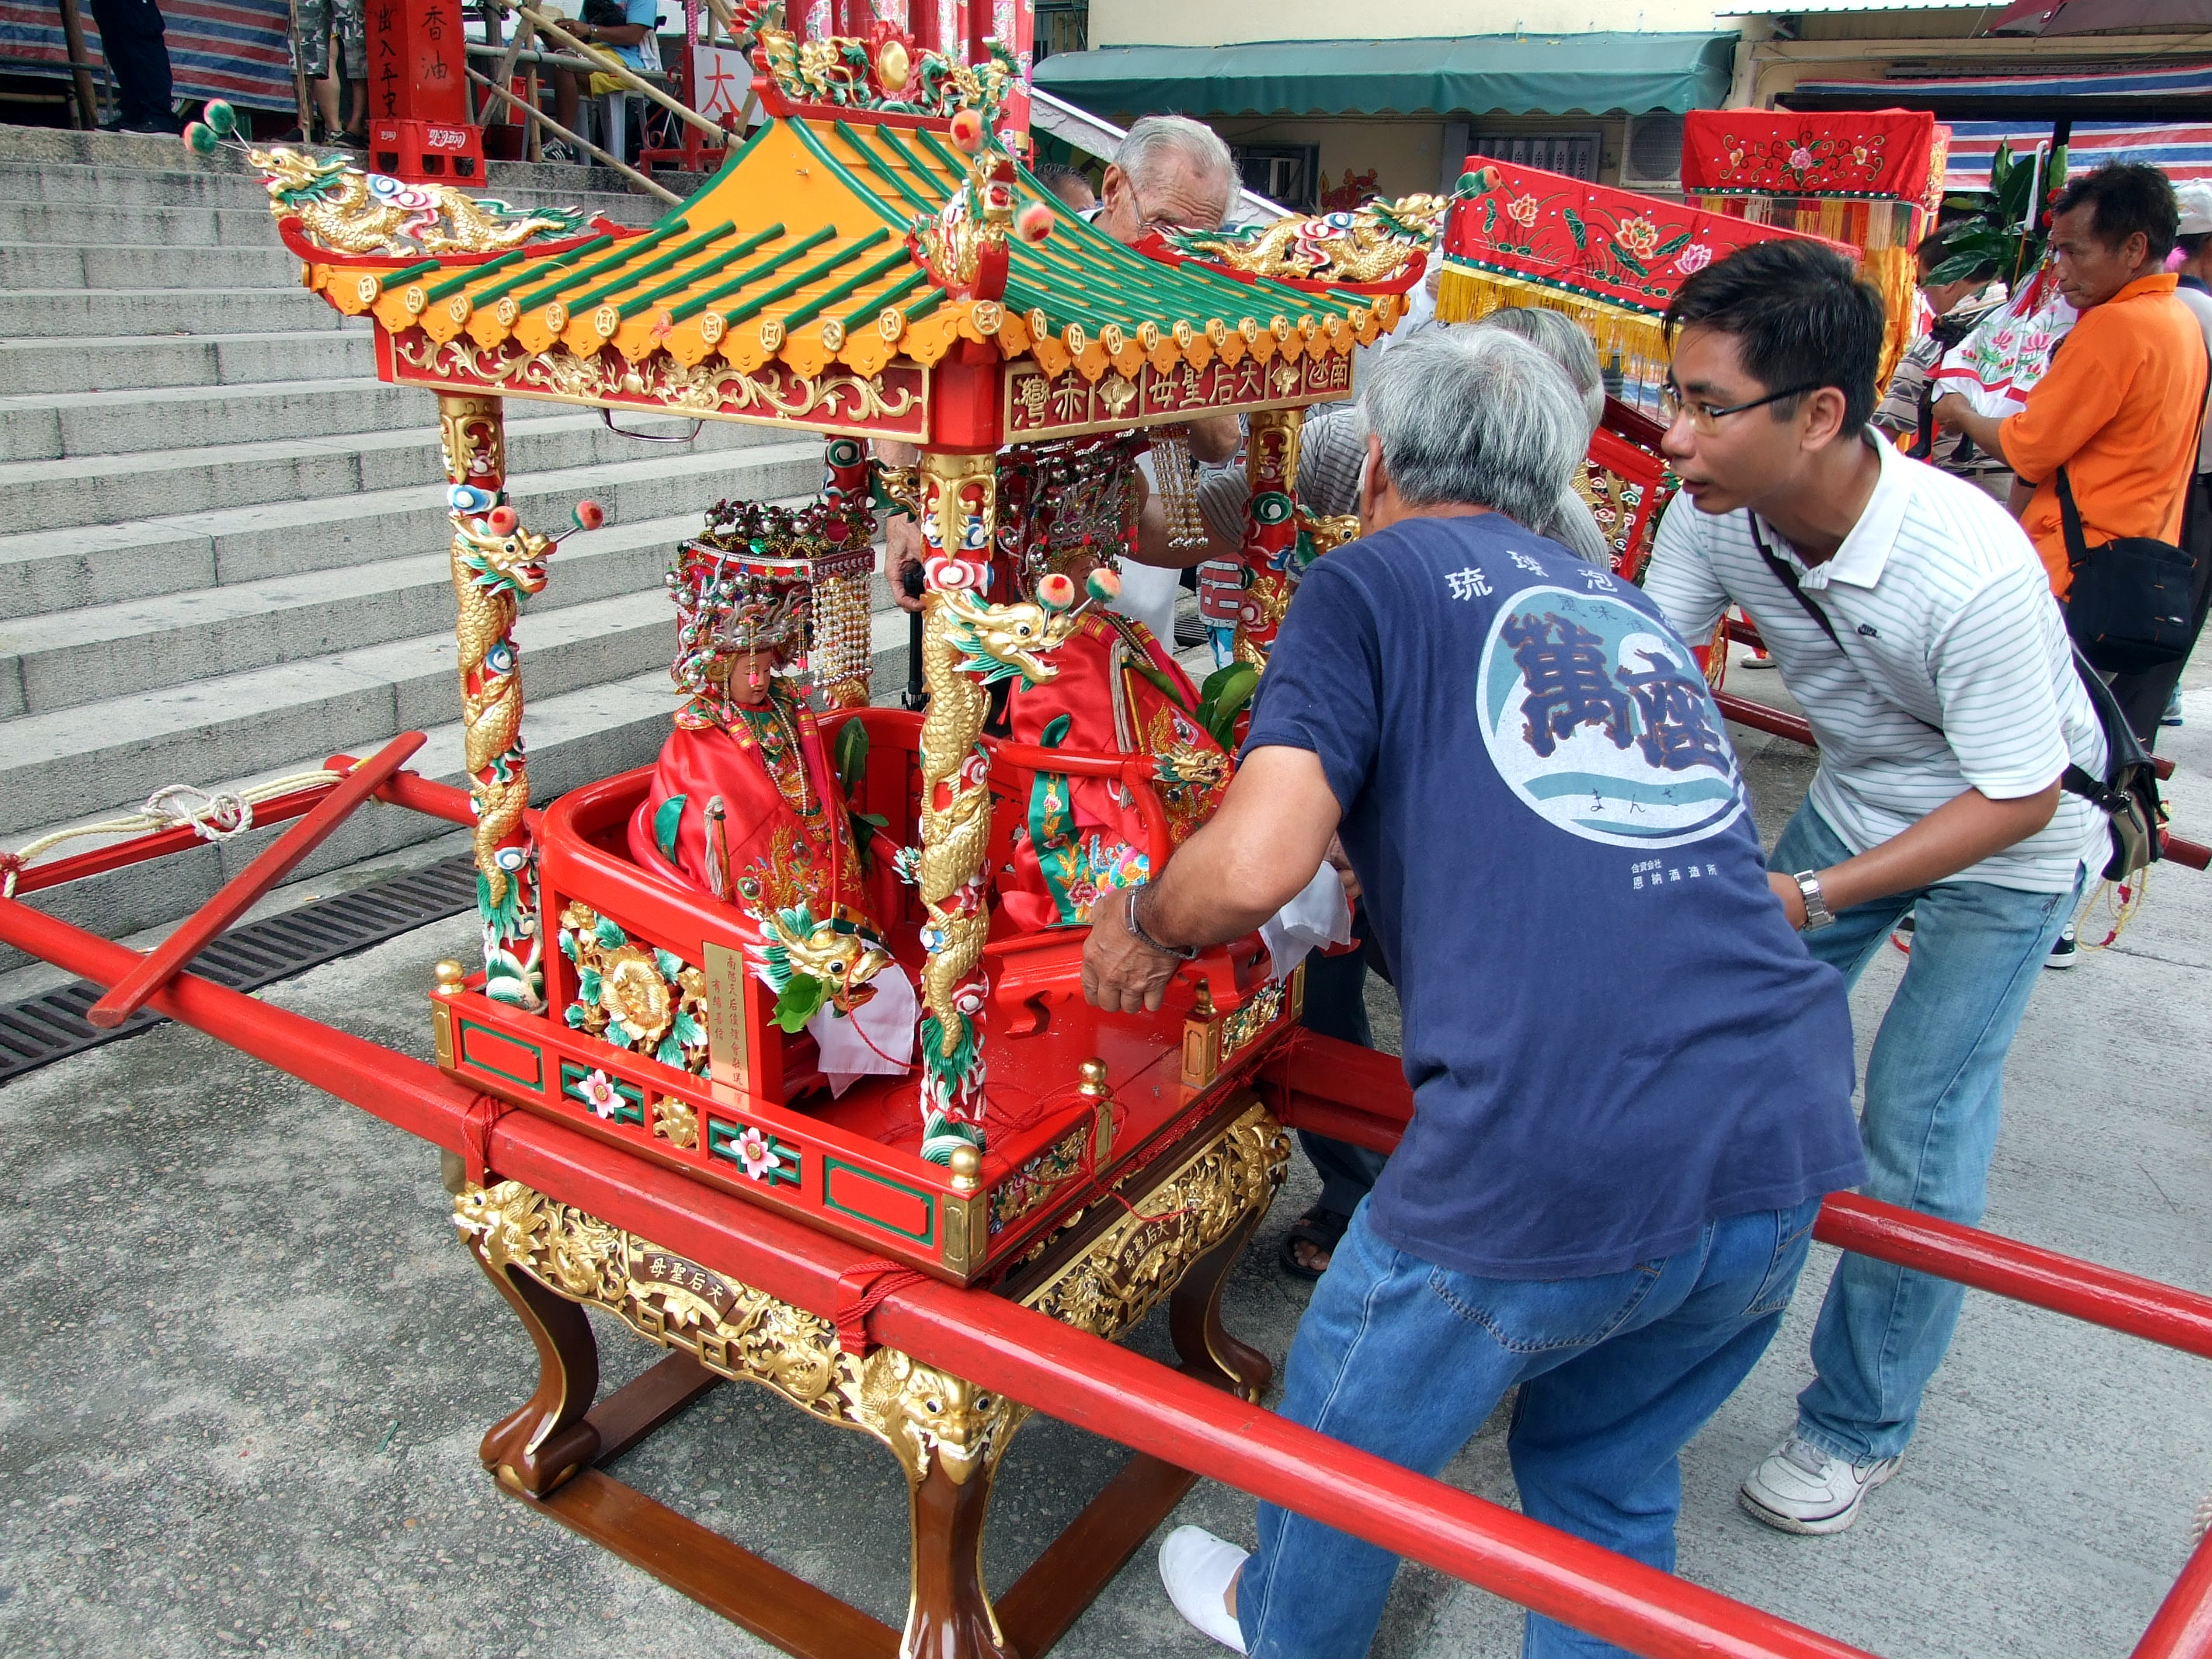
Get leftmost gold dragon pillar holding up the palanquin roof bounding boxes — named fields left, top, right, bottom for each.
left=438, top=394, right=551, bottom=1009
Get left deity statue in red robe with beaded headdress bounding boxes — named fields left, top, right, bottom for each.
left=628, top=502, right=916, bottom=1082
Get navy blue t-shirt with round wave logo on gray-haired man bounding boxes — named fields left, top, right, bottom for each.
left=1245, top=513, right=1865, bottom=1278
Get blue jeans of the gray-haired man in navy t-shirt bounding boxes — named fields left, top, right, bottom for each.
left=1236, top=1199, right=1821, bottom=1659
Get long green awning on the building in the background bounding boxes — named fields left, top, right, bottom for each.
left=1035, top=33, right=1737, bottom=115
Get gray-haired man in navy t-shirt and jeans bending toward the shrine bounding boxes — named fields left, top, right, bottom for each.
left=1084, top=329, right=1865, bottom=1659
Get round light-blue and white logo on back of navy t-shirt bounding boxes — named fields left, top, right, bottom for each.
left=1477, top=586, right=1745, bottom=847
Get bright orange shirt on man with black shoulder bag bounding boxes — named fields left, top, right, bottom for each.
left=1998, top=274, right=2205, bottom=600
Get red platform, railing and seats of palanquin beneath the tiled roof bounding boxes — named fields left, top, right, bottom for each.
left=433, top=708, right=1301, bottom=1283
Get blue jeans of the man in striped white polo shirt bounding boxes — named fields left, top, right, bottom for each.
left=1768, top=805, right=2084, bottom=1460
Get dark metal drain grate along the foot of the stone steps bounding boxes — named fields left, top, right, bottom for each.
left=0, top=854, right=475, bottom=1084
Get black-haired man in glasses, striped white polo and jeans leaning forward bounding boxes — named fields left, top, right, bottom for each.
left=1646, top=241, right=2106, bottom=1533
